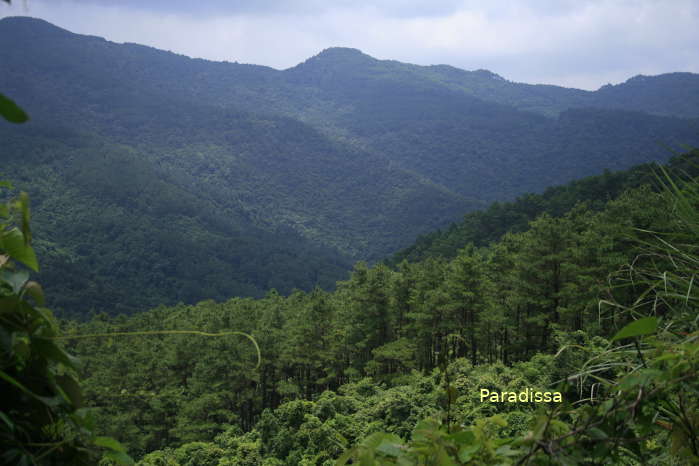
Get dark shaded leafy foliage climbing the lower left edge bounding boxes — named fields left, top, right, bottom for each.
left=0, top=183, right=133, bottom=465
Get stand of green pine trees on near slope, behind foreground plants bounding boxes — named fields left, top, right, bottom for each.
left=65, top=153, right=696, bottom=464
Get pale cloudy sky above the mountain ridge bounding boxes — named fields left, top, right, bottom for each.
left=0, top=0, right=699, bottom=89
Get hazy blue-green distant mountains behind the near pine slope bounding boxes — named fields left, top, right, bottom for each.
left=0, top=18, right=699, bottom=312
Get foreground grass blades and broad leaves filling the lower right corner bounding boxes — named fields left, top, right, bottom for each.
left=339, top=154, right=699, bottom=465
